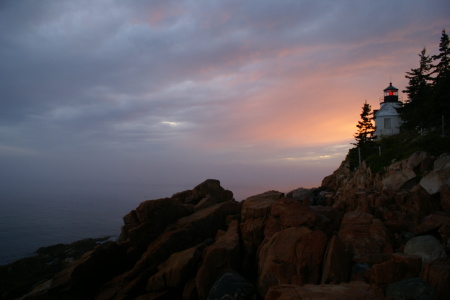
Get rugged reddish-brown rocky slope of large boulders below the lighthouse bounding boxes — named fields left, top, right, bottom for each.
left=0, top=152, right=450, bottom=300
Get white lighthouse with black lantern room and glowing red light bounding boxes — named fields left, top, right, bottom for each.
left=373, top=82, right=403, bottom=139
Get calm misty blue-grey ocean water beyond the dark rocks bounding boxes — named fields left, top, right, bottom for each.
left=0, top=180, right=261, bottom=265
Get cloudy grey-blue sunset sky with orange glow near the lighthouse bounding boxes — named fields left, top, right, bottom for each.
left=0, top=0, right=450, bottom=200
